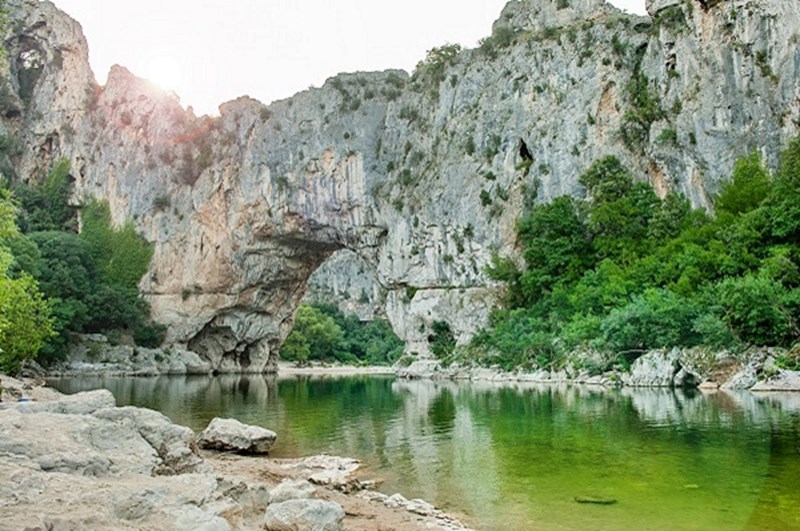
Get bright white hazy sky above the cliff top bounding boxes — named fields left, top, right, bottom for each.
left=54, top=0, right=644, bottom=114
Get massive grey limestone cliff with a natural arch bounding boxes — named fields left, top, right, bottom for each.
left=0, top=0, right=800, bottom=372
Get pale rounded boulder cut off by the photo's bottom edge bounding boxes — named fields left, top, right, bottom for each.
left=264, top=499, right=344, bottom=531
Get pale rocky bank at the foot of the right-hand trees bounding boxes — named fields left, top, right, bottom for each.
left=396, top=348, right=800, bottom=392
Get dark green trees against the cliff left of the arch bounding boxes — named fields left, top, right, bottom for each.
left=0, top=170, right=165, bottom=362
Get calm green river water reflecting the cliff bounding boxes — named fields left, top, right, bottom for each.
left=53, top=377, right=800, bottom=531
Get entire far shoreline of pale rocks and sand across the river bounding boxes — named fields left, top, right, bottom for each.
left=23, top=335, right=800, bottom=391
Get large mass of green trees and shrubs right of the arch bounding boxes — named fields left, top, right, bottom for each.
left=473, top=140, right=800, bottom=374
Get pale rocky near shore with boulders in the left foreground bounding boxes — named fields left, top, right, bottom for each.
left=0, top=376, right=466, bottom=531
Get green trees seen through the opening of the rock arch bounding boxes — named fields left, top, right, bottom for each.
left=280, top=304, right=403, bottom=365
